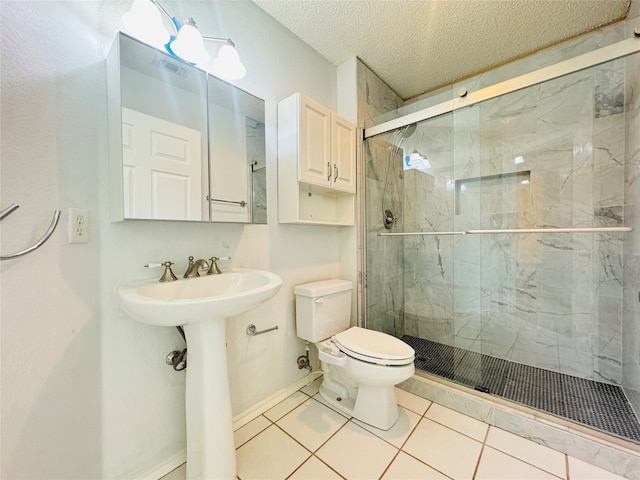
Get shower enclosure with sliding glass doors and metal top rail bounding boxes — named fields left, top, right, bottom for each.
left=364, top=39, right=640, bottom=443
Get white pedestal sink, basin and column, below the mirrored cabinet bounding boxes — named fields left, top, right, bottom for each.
left=118, top=269, right=282, bottom=480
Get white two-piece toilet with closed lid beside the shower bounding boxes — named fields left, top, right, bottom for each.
left=294, top=279, right=415, bottom=430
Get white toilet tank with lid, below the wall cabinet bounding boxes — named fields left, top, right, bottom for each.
left=293, top=279, right=353, bottom=342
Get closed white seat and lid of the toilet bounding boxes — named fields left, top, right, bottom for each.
left=332, top=327, right=415, bottom=365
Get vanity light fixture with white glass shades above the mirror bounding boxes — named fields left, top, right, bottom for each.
left=122, top=0, right=247, bottom=80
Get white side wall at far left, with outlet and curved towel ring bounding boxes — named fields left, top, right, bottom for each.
left=0, top=1, right=105, bottom=479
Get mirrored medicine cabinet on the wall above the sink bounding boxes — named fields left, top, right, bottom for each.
left=107, top=33, right=267, bottom=223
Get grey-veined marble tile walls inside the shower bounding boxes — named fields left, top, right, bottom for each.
left=365, top=22, right=640, bottom=386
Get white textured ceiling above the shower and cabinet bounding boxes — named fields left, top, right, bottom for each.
left=254, top=0, right=630, bottom=100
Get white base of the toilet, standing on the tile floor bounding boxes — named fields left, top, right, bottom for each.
left=320, top=376, right=398, bottom=430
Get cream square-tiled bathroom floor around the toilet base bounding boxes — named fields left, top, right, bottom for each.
left=162, top=379, right=622, bottom=480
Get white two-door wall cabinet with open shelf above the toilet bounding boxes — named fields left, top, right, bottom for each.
left=278, top=93, right=356, bottom=225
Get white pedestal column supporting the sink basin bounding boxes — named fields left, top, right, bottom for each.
left=183, top=318, right=236, bottom=480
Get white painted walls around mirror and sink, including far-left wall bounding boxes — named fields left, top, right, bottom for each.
left=0, top=0, right=355, bottom=479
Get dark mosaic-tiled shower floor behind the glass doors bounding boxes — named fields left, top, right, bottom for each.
left=402, top=335, right=640, bottom=443
